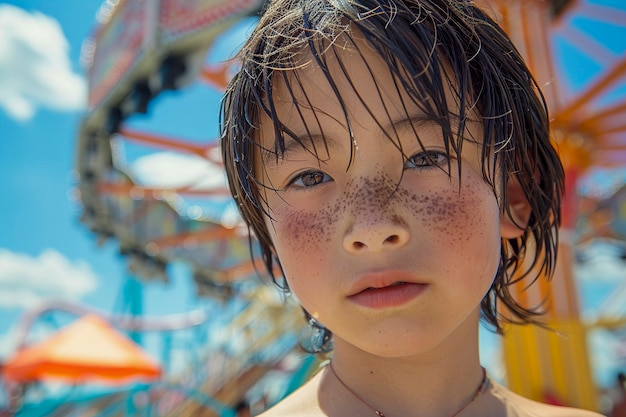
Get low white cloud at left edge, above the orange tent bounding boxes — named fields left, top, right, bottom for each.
left=0, top=249, right=98, bottom=309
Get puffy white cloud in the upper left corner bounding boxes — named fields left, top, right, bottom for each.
left=0, top=4, right=87, bottom=121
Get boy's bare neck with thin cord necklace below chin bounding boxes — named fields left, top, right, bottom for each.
left=320, top=328, right=483, bottom=417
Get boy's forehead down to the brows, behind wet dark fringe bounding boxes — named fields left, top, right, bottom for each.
left=259, top=33, right=466, bottom=158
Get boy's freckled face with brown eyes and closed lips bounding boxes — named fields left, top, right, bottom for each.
left=257, top=40, right=500, bottom=356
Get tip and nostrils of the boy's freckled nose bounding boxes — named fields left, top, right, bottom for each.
left=343, top=217, right=409, bottom=255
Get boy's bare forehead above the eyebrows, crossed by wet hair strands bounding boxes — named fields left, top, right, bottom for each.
left=266, top=36, right=458, bottom=125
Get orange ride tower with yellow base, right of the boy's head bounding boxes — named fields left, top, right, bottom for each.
left=478, top=0, right=598, bottom=411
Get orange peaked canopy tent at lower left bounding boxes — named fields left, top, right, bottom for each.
left=2, top=315, right=161, bottom=384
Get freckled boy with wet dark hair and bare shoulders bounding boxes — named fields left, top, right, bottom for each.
left=222, top=0, right=596, bottom=417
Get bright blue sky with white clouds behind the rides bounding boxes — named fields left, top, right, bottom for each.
left=0, top=0, right=626, bottom=394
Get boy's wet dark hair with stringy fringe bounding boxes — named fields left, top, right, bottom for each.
left=221, top=0, right=564, bottom=342
